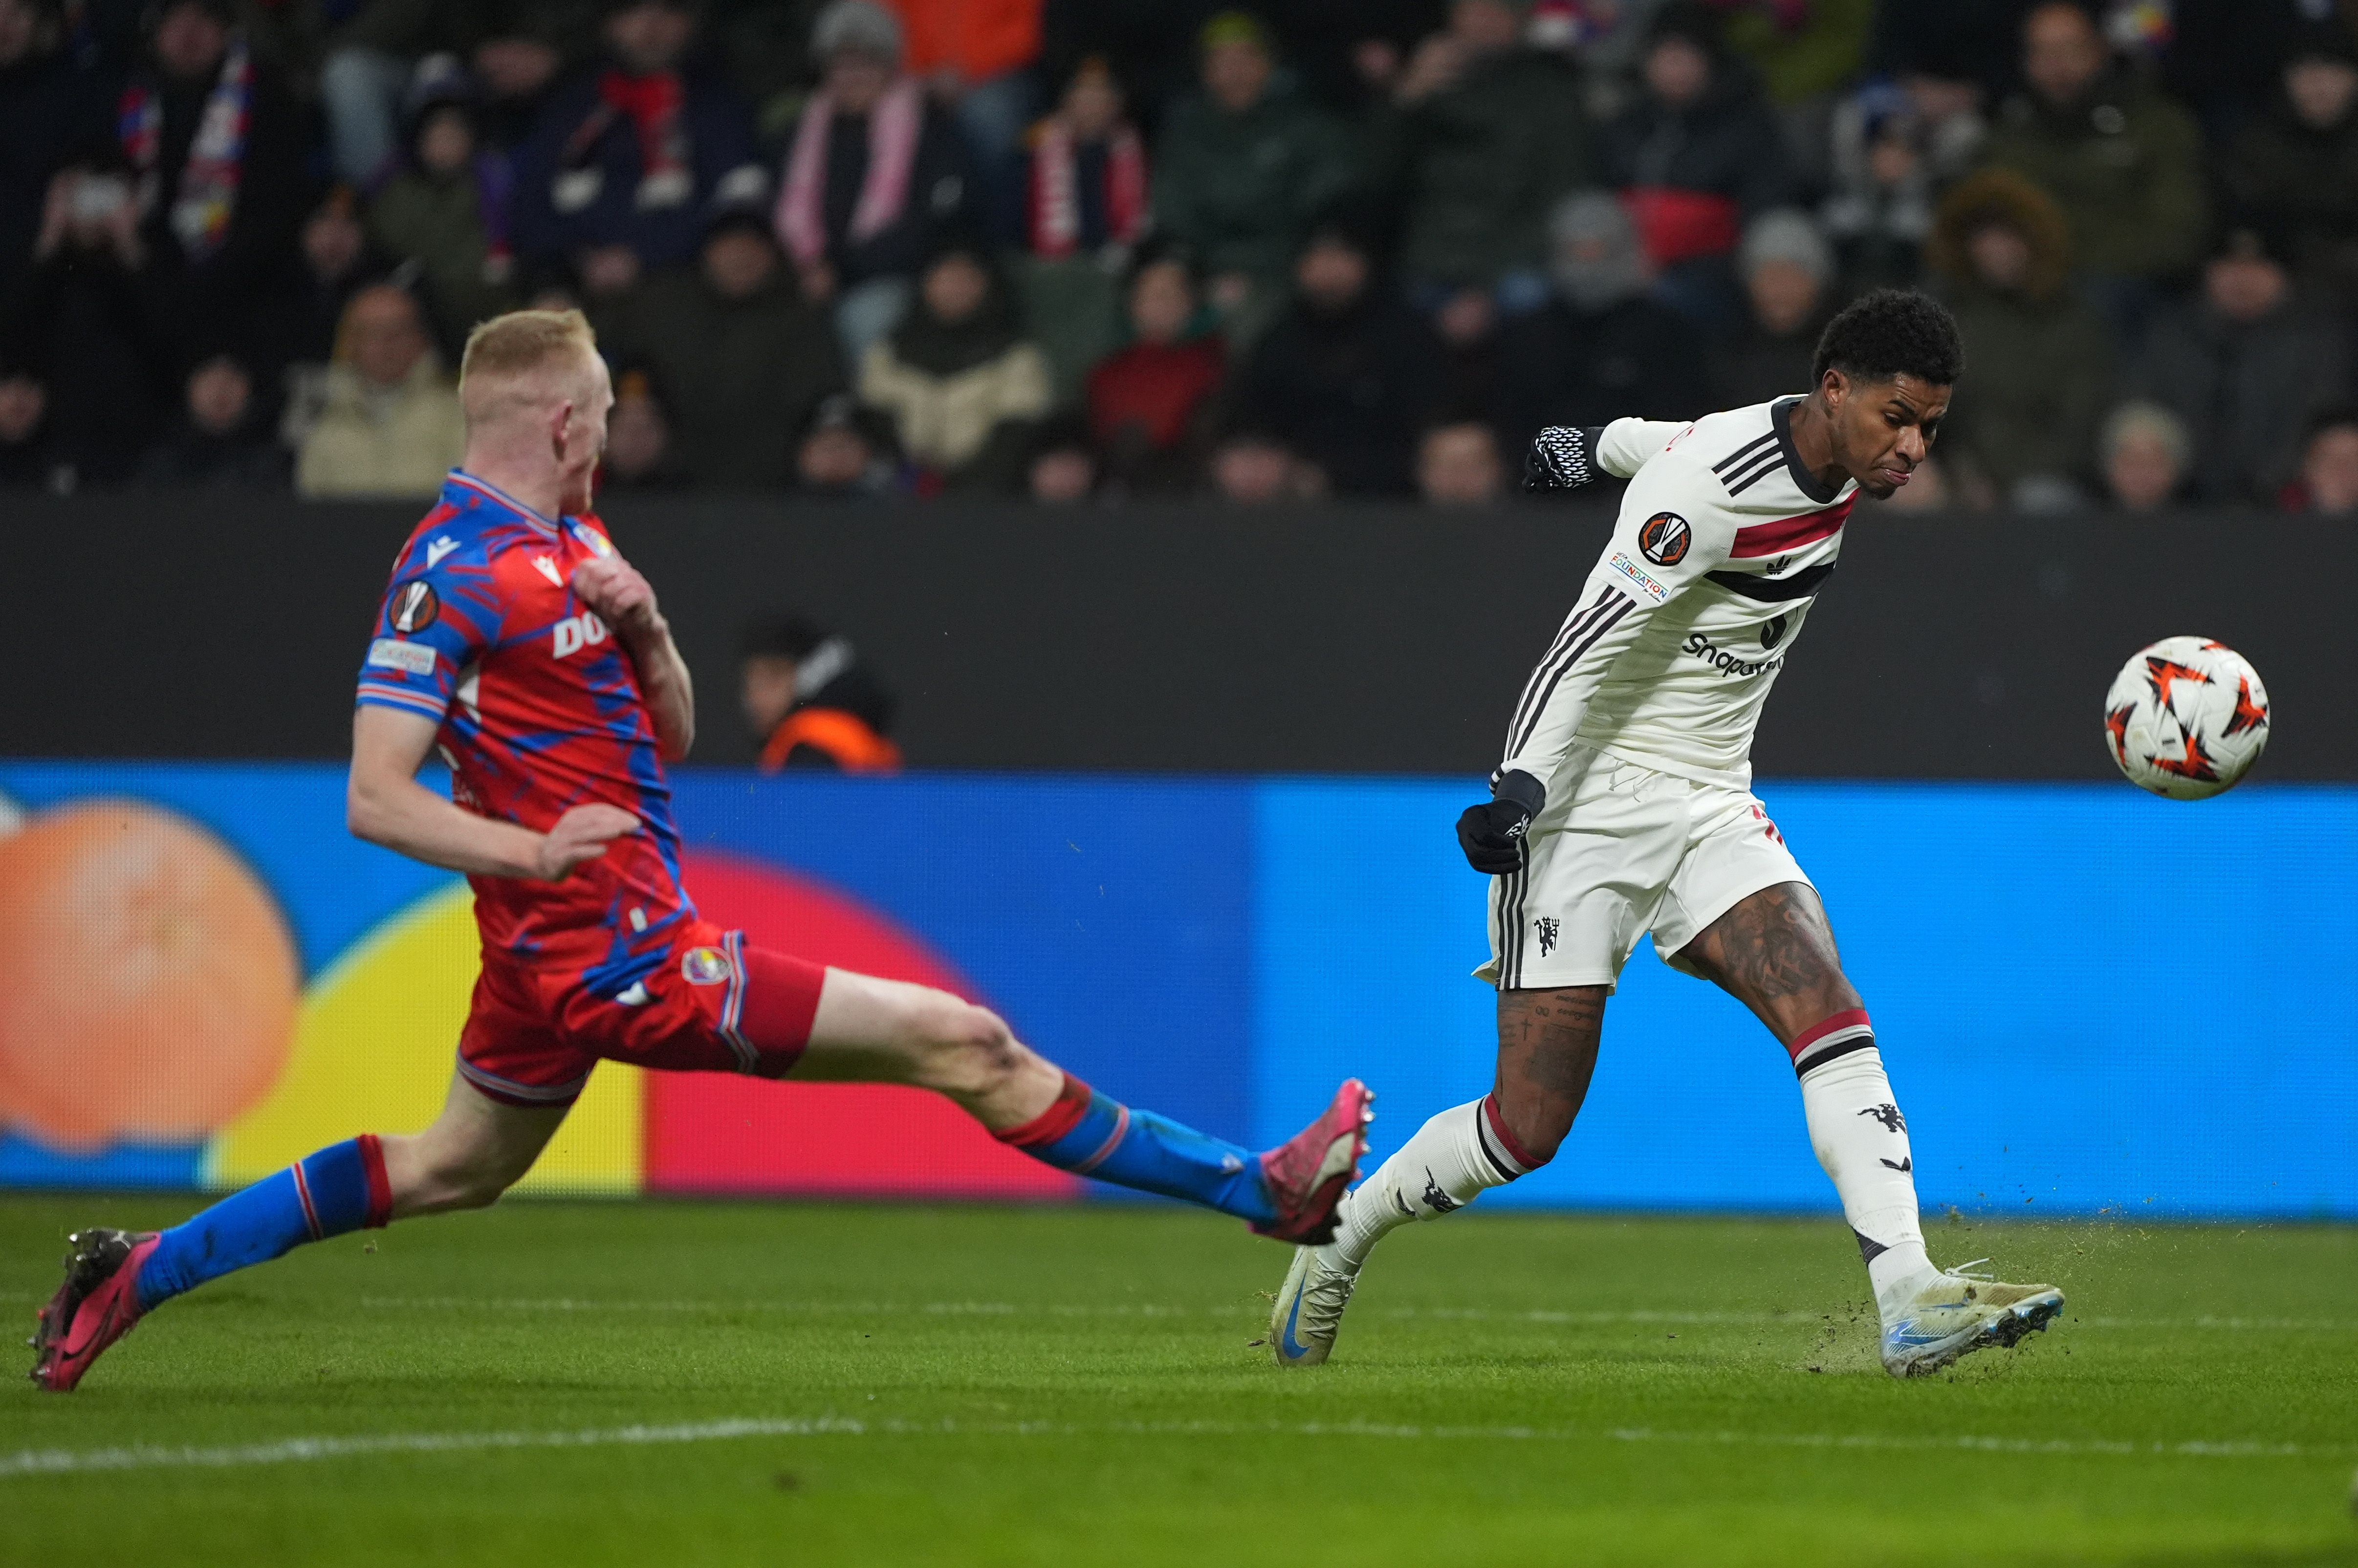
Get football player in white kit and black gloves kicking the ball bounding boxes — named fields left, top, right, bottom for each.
left=1268, top=290, right=2063, bottom=1377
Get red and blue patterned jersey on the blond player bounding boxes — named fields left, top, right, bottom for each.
left=358, top=472, right=696, bottom=998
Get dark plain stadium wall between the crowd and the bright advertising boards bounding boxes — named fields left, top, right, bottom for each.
left=0, top=495, right=2358, bottom=781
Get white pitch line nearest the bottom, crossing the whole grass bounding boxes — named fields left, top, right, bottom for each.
left=0, top=1415, right=2358, bottom=1481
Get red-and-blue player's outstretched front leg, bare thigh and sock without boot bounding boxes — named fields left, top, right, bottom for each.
left=787, top=969, right=1278, bottom=1224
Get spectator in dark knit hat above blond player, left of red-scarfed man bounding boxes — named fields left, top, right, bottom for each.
left=368, top=57, right=516, bottom=361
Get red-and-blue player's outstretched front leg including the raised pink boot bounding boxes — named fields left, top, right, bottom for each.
left=790, top=969, right=1375, bottom=1240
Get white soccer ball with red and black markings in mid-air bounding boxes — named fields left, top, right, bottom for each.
left=2103, top=636, right=2269, bottom=799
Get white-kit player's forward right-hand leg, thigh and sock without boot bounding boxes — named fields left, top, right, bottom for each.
left=1674, top=882, right=1934, bottom=1318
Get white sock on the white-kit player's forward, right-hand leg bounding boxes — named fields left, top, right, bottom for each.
left=1802, top=1037, right=1938, bottom=1320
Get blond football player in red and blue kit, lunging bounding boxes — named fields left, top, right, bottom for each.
left=33, top=311, right=1373, bottom=1391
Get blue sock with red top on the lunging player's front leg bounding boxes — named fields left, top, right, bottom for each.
left=998, top=1073, right=1278, bottom=1224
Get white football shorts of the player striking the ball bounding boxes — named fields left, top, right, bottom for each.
left=1474, top=747, right=1809, bottom=990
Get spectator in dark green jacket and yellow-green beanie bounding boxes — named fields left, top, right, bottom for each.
left=1156, top=12, right=1356, bottom=344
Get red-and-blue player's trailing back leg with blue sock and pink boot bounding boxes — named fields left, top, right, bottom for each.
left=26, top=1078, right=566, bottom=1394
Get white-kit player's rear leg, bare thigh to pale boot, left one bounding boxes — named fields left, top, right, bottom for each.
left=1268, top=985, right=1606, bottom=1368
